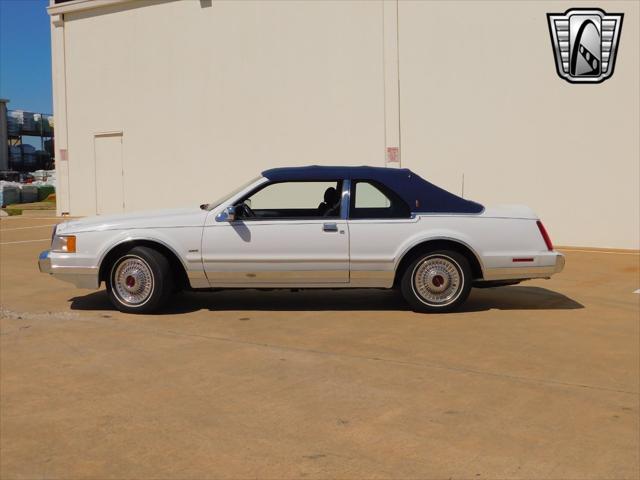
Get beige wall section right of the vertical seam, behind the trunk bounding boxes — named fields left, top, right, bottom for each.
left=399, top=1, right=640, bottom=249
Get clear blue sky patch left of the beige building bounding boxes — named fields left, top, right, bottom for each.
left=0, top=0, right=53, bottom=113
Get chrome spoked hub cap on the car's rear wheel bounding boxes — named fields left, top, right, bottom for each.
left=413, top=257, right=462, bottom=305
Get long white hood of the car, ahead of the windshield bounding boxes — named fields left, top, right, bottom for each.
left=57, top=207, right=209, bottom=233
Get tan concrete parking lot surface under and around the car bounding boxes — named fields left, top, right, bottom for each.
left=0, top=217, right=640, bottom=479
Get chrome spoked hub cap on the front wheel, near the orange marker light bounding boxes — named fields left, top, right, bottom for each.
left=113, top=257, right=153, bottom=305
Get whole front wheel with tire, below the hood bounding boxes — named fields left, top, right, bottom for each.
left=107, top=247, right=174, bottom=313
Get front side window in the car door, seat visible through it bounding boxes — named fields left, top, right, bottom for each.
left=238, top=180, right=342, bottom=220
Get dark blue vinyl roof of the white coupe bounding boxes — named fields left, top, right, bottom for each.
left=262, top=165, right=484, bottom=213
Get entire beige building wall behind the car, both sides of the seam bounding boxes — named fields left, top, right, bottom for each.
left=50, top=0, right=640, bottom=248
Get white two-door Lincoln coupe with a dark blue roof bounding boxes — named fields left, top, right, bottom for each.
left=39, top=166, right=564, bottom=313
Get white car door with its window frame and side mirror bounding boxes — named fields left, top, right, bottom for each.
left=202, top=180, right=349, bottom=287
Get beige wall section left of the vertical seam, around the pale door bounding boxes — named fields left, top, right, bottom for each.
left=51, top=1, right=385, bottom=215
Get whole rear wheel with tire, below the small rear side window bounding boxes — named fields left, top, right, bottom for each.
left=400, top=250, right=472, bottom=312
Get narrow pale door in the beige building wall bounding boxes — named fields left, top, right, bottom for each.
left=93, top=132, right=124, bottom=215
